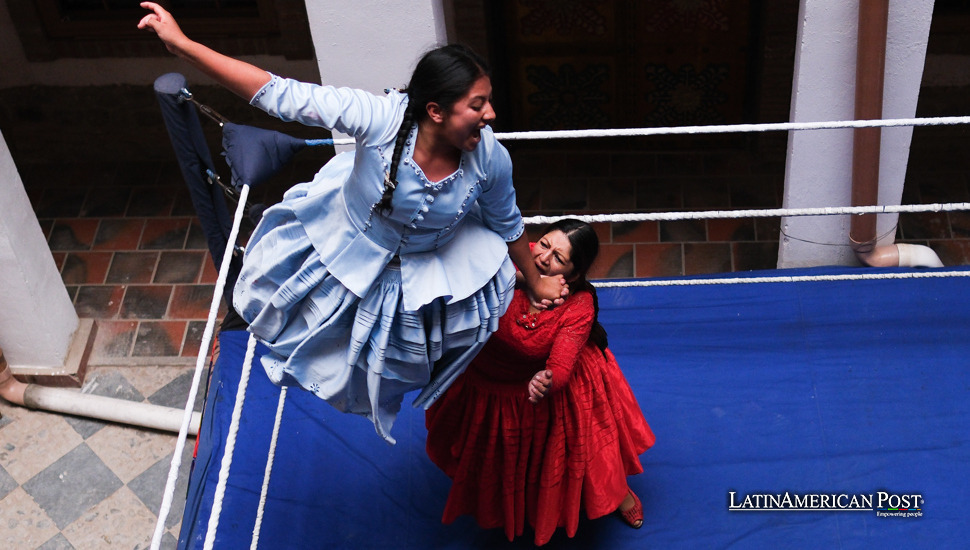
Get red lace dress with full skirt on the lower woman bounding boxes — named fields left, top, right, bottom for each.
left=425, top=290, right=654, bottom=545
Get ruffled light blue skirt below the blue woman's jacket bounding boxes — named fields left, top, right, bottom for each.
left=234, top=208, right=515, bottom=443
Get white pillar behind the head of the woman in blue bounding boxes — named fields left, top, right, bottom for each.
left=306, top=0, right=447, bottom=150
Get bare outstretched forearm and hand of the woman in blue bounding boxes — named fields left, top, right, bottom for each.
left=138, top=2, right=270, bottom=101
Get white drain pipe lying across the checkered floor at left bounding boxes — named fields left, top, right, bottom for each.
left=0, top=349, right=202, bottom=435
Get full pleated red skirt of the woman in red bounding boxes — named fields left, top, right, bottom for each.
left=425, top=344, right=655, bottom=545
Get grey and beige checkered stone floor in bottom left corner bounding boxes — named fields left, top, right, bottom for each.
left=0, top=366, right=201, bottom=550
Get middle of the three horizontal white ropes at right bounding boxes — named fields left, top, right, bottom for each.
left=522, top=202, right=970, bottom=225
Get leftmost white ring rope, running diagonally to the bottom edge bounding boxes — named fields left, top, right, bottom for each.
left=151, top=185, right=249, bottom=550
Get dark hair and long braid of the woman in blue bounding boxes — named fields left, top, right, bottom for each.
left=375, top=44, right=489, bottom=215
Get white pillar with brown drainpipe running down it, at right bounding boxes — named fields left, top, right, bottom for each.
left=778, top=0, right=933, bottom=268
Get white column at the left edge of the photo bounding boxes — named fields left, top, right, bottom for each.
left=0, top=130, right=79, bottom=375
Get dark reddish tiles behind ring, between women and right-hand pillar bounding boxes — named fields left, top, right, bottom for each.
left=510, top=136, right=784, bottom=278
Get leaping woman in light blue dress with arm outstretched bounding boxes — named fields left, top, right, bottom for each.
left=138, top=2, right=567, bottom=443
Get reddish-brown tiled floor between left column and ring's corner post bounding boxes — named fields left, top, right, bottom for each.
left=31, top=165, right=232, bottom=364
